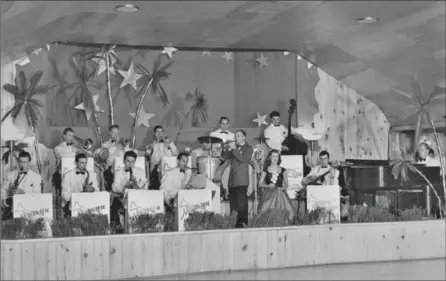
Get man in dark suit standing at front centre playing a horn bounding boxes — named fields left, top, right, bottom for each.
left=222, top=130, right=254, bottom=227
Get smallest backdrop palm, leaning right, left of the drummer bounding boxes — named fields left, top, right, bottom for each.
left=175, top=87, right=209, bottom=144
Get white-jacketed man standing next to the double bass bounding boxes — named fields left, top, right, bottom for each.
left=264, top=111, right=289, bottom=151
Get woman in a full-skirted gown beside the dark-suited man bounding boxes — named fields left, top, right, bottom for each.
left=258, top=149, right=294, bottom=221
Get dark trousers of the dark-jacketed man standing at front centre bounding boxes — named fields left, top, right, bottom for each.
left=228, top=186, right=248, bottom=227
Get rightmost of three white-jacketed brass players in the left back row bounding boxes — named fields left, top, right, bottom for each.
left=150, top=125, right=178, bottom=189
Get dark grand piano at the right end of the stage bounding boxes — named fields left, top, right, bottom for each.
left=339, top=159, right=444, bottom=213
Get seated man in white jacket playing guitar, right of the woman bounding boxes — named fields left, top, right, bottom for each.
left=302, top=150, right=339, bottom=186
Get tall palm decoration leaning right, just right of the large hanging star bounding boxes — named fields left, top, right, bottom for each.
left=130, top=55, right=173, bottom=147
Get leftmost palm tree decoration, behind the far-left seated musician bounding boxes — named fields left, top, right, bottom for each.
left=1, top=71, right=49, bottom=173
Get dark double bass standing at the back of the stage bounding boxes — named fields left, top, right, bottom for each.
left=282, top=99, right=311, bottom=175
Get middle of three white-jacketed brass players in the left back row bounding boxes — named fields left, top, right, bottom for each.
left=102, top=124, right=120, bottom=191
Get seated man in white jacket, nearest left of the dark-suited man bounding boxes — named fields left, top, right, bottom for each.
left=160, top=153, right=192, bottom=210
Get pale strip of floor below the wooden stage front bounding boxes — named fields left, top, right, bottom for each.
left=138, top=259, right=446, bottom=280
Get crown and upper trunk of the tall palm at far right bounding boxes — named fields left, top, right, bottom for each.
left=393, top=75, right=446, bottom=154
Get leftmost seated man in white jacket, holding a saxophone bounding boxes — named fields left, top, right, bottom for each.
left=1, top=151, right=42, bottom=219
